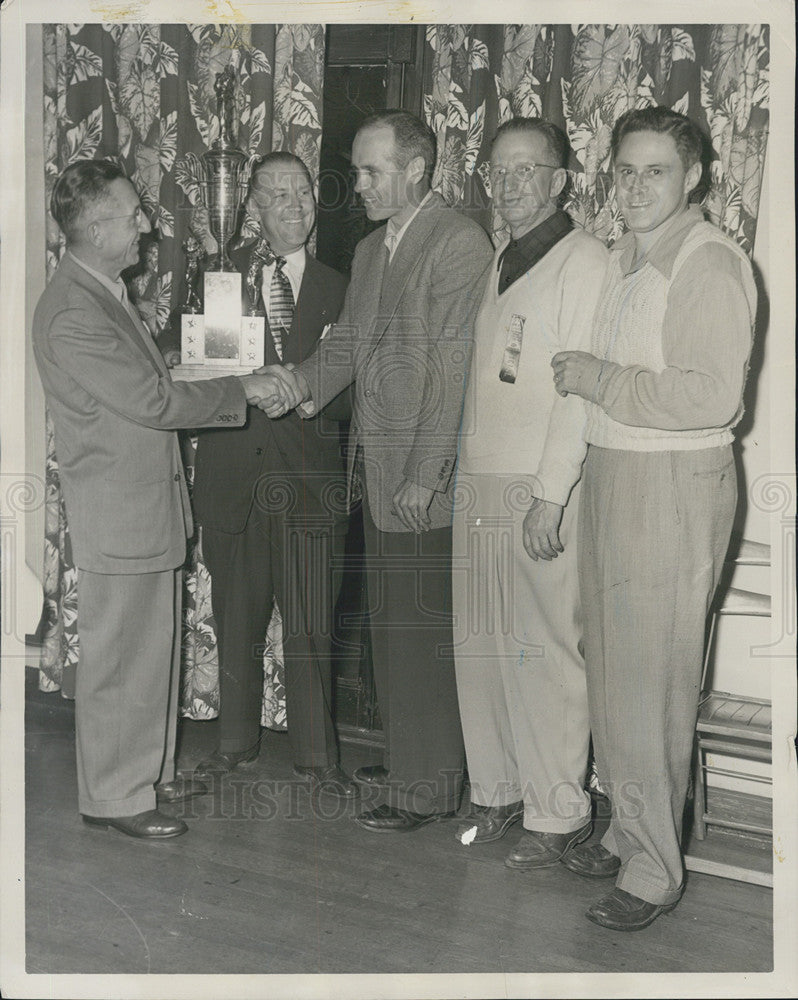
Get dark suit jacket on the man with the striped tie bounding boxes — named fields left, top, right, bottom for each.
left=194, top=244, right=349, bottom=534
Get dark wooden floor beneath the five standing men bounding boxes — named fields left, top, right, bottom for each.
left=26, top=670, right=772, bottom=974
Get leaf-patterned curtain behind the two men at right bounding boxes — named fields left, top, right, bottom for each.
left=424, top=24, right=769, bottom=253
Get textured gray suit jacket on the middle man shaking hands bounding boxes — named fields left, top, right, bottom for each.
left=300, top=193, right=493, bottom=531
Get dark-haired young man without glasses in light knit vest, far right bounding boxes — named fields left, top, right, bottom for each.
left=552, top=107, right=756, bottom=931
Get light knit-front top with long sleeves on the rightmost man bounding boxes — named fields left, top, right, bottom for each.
left=585, top=206, right=756, bottom=451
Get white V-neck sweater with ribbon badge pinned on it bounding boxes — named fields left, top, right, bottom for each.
left=459, top=229, right=607, bottom=505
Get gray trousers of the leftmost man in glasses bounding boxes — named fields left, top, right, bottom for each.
left=75, top=570, right=182, bottom=816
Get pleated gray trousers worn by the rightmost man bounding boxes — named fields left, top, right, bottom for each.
left=579, top=445, right=737, bottom=904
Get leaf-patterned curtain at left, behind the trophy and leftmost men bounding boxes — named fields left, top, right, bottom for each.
left=40, top=24, right=324, bottom=727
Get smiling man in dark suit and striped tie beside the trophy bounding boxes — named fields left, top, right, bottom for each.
left=187, top=152, right=357, bottom=798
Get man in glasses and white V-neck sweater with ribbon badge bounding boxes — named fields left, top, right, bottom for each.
left=453, top=118, right=607, bottom=870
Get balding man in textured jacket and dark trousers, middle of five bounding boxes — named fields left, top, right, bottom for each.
left=266, top=111, right=492, bottom=833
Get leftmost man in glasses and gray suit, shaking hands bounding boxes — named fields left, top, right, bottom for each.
left=33, top=160, right=294, bottom=839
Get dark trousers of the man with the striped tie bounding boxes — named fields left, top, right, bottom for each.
left=202, top=507, right=344, bottom=767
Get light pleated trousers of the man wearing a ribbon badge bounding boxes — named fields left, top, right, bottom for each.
left=452, top=472, right=590, bottom=833
